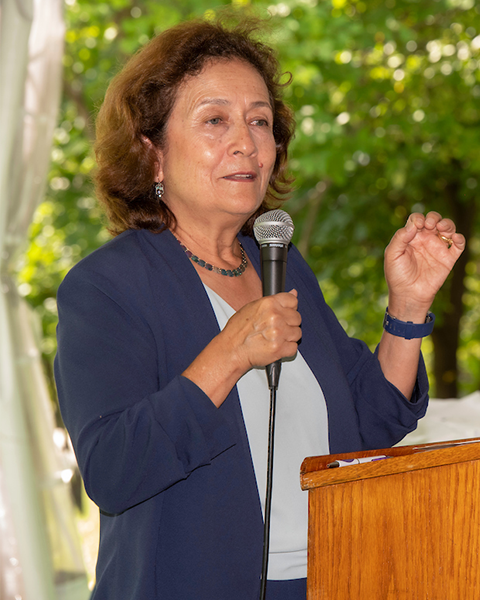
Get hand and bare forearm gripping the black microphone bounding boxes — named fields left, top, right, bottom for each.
left=182, top=290, right=302, bottom=406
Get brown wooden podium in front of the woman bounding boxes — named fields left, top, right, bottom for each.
left=301, top=438, right=480, bottom=600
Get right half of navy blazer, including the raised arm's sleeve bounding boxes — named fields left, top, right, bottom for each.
left=286, top=243, right=428, bottom=452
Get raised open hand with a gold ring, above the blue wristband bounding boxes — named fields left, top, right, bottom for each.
left=385, top=212, right=465, bottom=322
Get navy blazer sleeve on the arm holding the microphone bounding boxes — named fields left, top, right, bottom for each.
left=55, top=266, right=236, bottom=514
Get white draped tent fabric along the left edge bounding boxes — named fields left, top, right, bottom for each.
left=0, top=0, right=88, bottom=600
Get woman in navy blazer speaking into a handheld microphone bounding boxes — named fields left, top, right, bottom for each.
left=56, top=16, right=465, bottom=600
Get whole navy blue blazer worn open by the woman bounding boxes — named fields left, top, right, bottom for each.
left=55, top=230, right=428, bottom=600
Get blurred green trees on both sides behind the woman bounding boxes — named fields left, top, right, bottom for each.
left=18, top=0, right=480, bottom=404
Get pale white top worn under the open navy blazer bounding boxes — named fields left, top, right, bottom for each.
left=205, top=286, right=329, bottom=580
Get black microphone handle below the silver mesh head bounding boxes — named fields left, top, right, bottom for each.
left=260, top=243, right=288, bottom=390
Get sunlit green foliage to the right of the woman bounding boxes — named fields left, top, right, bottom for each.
left=270, top=0, right=480, bottom=392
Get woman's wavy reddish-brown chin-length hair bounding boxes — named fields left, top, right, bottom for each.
left=95, top=18, right=295, bottom=235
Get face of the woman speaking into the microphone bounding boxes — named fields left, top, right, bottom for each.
left=158, top=60, right=276, bottom=224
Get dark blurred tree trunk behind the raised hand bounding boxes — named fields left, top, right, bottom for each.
left=432, top=176, right=476, bottom=398
